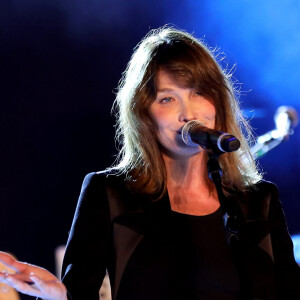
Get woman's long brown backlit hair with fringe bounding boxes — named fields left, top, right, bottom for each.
left=109, top=27, right=261, bottom=197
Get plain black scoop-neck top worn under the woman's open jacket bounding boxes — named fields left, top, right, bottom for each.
left=117, top=201, right=240, bottom=300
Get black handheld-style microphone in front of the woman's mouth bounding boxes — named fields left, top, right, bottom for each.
left=181, top=120, right=240, bottom=153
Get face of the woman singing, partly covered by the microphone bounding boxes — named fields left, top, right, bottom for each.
left=149, top=70, right=216, bottom=158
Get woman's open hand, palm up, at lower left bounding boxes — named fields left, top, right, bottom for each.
left=0, top=251, right=67, bottom=300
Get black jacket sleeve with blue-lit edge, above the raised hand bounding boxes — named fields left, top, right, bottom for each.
left=62, top=173, right=112, bottom=300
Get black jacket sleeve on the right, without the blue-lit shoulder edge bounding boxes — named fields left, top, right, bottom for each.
left=269, top=185, right=300, bottom=300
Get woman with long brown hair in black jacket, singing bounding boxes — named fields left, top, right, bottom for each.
left=0, top=27, right=300, bottom=300
